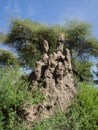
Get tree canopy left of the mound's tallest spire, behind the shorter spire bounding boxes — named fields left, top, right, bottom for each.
left=6, top=19, right=65, bottom=67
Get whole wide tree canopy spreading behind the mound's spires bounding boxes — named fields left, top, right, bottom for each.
left=6, top=19, right=98, bottom=81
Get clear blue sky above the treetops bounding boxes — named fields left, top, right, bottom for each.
left=0, top=0, right=98, bottom=37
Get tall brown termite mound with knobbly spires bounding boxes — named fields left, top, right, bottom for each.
left=26, top=34, right=76, bottom=121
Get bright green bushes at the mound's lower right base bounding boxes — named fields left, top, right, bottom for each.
left=34, top=82, right=98, bottom=130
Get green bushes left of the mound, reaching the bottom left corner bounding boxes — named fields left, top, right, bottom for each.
left=0, top=67, right=43, bottom=130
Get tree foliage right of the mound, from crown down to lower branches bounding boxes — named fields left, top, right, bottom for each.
left=65, top=19, right=98, bottom=81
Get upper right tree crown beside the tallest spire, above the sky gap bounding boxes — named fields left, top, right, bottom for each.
left=65, top=19, right=98, bottom=59
